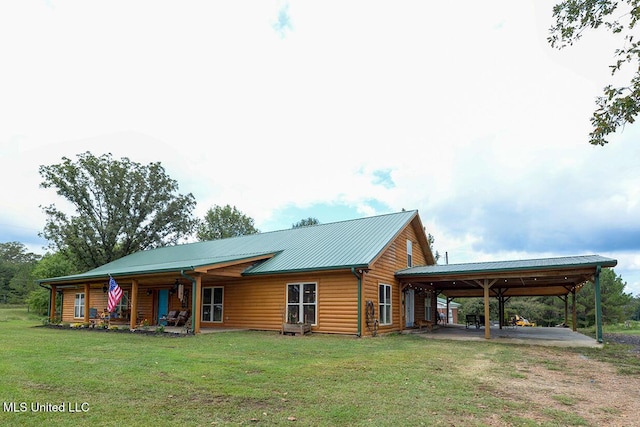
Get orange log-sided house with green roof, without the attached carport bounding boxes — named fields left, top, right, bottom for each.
left=41, top=211, right=437, bottom=336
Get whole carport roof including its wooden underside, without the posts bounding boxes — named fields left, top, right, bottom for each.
left=396, top=255, right=618, bottom=297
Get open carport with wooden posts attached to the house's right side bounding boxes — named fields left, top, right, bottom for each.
left=395, top=255, right=618, bottom=343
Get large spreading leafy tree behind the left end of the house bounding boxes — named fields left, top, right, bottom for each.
left=40, top=152, right=196, bottom=270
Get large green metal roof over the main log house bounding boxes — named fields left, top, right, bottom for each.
left=40, top=211, right=418, bottom=283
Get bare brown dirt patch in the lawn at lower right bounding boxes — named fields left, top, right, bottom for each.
left=487, top=346, right=640, bottom=427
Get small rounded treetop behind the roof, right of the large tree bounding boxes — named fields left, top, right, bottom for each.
left=196, top=205, right=260, bottom=241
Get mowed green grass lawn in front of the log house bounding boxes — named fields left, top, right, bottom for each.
left=0, top=308, right=636, bottom=426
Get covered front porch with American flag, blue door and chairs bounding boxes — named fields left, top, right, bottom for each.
left=44, top=253, right=273, bottom=333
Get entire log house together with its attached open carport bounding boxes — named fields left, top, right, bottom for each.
left=40, top=211, right=617, bottom=342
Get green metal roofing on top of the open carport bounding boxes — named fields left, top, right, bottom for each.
left=396, top=255, right=618, bottom=277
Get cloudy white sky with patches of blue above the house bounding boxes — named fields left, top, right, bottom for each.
left=0, top=0, right=640, bottom=295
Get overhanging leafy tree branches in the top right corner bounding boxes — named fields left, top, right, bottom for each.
left=548, top=0, right=640, bottom=145
